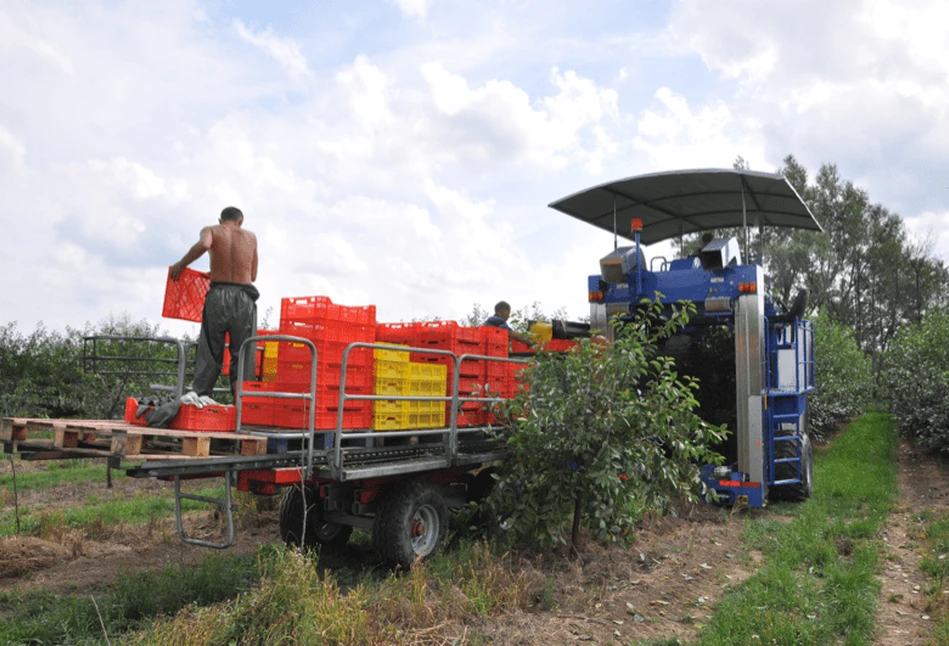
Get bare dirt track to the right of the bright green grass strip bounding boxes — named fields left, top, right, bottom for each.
left=877, top=442, right=949, bottom=646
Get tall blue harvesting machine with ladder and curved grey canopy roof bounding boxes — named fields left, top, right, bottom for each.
left=551, top=170, right=822, bottom=507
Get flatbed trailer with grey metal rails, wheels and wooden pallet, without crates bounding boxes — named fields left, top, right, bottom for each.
left=0, top=335, right=524, bottom=569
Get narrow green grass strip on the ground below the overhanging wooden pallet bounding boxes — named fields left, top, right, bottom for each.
left=0, top=487, right=224, bottom=536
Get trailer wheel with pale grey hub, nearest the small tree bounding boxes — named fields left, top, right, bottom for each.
left=372, top=480, right=448, bottom=570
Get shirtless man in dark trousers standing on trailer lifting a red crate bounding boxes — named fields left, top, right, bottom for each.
left=171, top=206, right=260, bottom=396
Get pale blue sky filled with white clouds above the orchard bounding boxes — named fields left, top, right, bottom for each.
left=0, top=0, right=949, bottom=335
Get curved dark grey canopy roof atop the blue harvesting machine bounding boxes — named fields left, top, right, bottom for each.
left=550, top=169, right=823, bottom=245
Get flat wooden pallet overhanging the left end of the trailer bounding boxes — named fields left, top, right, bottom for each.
left=0, top=418, right=267, bottom=460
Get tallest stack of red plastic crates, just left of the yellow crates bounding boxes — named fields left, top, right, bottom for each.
left=274, top=296, right=376, bottom=429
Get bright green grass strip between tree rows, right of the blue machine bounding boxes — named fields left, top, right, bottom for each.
left=699, top=414, right=897, bottom=646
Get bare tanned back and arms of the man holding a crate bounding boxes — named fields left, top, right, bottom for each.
left=171, top=211, right=257, bottom=285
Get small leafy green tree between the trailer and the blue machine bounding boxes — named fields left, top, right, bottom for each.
left=488, top=303, right=725, bottom=549
